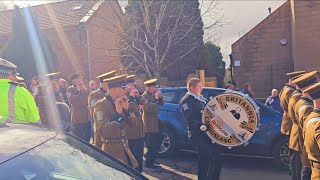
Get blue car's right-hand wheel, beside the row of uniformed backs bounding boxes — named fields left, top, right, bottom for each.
left=272, top=138, right=290, bottom=169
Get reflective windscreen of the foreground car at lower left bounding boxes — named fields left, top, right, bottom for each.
left=0, top=135, right=133, bottom=180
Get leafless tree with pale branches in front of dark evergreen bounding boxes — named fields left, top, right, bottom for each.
left=121, top=0, right=225, bottom=77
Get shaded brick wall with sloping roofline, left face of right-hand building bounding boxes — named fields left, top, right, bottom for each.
left=232, top=2, right=293, bottom=97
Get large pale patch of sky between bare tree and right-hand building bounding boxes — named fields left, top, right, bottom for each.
left=214, top=0, right=286, bottom=65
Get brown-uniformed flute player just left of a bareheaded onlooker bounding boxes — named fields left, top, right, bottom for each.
left=67, top=73, right=91, bottom=142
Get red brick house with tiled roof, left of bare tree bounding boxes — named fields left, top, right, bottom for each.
left=0, top=0, right=122, bottom=79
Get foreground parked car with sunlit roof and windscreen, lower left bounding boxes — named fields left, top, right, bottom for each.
left=0, top=123, right=147, bottom=180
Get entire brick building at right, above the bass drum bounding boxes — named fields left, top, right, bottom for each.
left=232, top=0, right=320, bottom=97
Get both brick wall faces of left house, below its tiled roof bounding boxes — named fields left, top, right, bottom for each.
left=41, top=1, right=120, bottom=81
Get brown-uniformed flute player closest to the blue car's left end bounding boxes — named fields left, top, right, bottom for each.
left=142, top=79, right=164, bottom=168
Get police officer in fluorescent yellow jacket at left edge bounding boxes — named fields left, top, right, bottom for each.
left=0, top=58, right=40, bottom=124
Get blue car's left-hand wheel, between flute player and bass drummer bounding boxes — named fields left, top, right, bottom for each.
left=158, top=129, right=175, bottom=156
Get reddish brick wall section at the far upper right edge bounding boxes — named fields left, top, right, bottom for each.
left=290, top=0, right=320, bottom=70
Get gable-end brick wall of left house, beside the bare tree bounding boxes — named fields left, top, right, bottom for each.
left=86, top=1, right=122, bottom=79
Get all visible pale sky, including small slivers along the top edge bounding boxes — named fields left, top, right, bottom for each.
left=8, top=0, right=286, bottom=66
